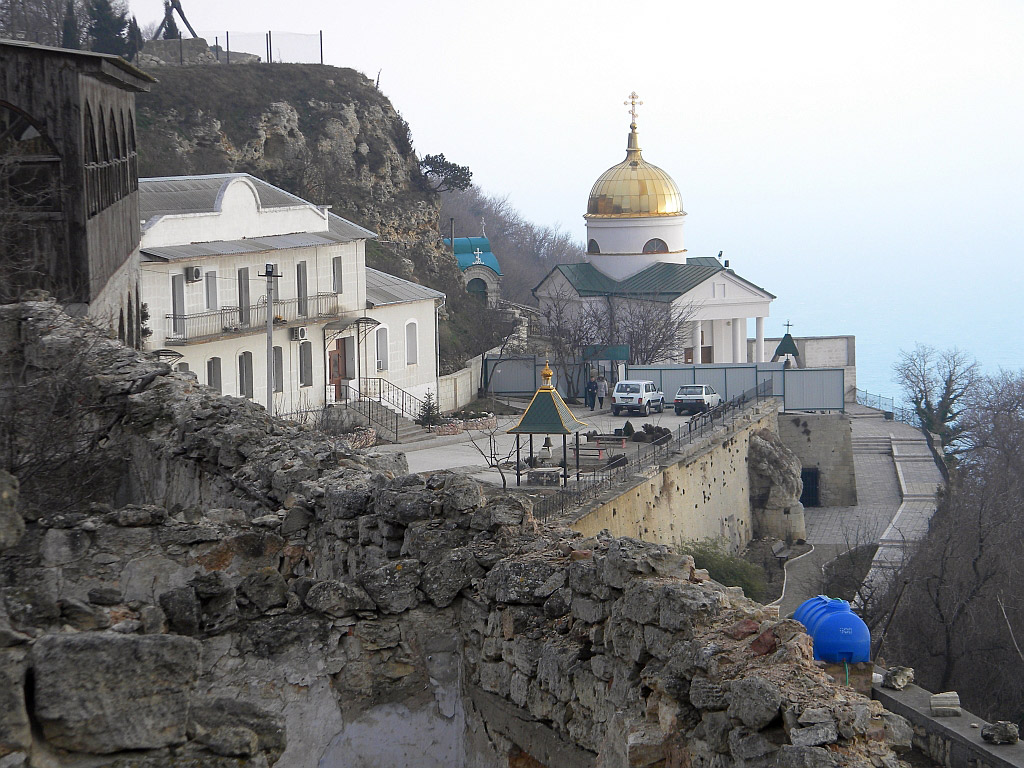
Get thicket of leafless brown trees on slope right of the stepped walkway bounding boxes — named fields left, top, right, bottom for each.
left=886, top=373, right=1024, bottom=719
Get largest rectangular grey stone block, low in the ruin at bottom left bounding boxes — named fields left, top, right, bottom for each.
left=32, top=633, right=201, bottom=755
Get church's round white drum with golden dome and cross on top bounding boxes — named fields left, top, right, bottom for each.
left=584, top=91, right=686, bottom=280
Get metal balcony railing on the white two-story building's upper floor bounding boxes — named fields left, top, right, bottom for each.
left=165, top=293, right=342, bottom=346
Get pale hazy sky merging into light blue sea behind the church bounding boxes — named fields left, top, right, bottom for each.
left=130, top=0, right=1024, bottom=394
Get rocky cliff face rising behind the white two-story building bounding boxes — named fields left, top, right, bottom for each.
left=137, top=65, right=458, bottom=282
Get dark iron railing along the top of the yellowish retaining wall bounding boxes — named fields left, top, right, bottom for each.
left=534, top=379, right=777, bottom=520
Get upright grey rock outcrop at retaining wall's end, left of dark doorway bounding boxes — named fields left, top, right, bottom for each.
left=748, top=429, right=807, bottom=541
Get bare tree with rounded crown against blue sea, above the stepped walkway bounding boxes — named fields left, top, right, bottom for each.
left=893, top=344, right=981, bottom=459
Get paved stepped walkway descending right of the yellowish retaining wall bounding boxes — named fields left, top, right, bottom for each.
left=779, top=404, right=942, bottom=615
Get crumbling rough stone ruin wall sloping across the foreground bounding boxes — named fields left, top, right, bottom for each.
left=0, top=302, right=909, bottom=768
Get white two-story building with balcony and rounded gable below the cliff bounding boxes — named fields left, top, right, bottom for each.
left=139, top=173, right=444, bottom=414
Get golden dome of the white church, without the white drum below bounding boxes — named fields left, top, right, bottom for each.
left=585, top=123, right=685, bottom=218
